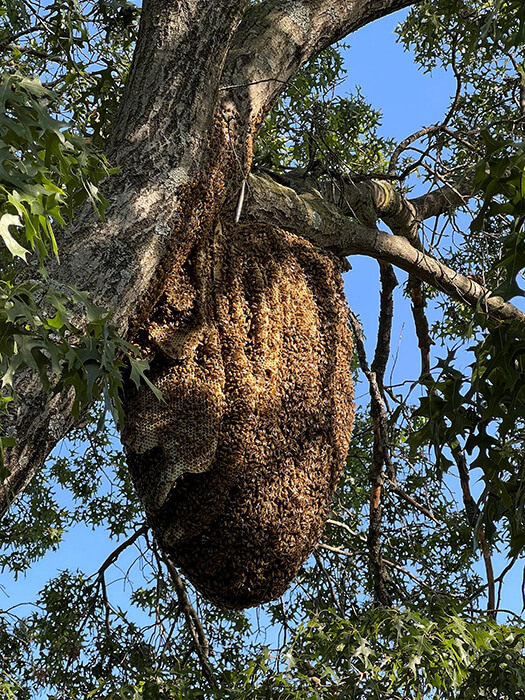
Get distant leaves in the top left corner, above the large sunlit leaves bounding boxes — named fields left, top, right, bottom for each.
left=0, top=0, right=140, bottom=147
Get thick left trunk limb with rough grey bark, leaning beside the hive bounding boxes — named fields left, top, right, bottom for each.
left=0, top=0, right=252, bottom=515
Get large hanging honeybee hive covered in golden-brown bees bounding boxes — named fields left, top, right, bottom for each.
left=123, top=220, right=354, bottom=608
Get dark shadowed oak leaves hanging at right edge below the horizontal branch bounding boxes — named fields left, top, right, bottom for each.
left=410, top=327, right=525, bottom=556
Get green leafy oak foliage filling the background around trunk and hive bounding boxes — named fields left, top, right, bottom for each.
left=0, top=0, right=525, bottom=700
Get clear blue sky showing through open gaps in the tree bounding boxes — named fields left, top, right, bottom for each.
left=0, top=5, right=521, bottom=672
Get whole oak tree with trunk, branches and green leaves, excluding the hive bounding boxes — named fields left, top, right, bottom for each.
left=0, top=0, right=525, bottom=698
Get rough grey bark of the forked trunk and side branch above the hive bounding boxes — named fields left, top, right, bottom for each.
left=4, top=0, right=494, bottom=514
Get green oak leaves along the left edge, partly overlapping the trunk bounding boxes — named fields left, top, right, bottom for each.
left=0, top=5, right=158, bottom=460
